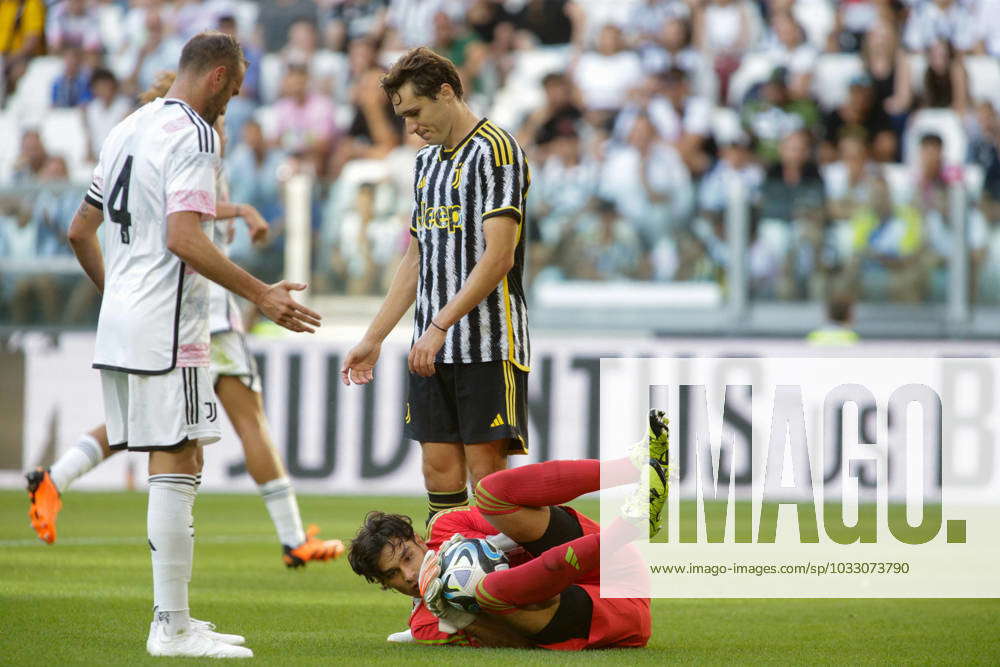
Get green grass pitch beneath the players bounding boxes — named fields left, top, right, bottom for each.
left=0, top=491, right=1000, bottom=665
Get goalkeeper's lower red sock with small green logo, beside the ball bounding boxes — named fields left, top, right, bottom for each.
left=476, top=533, right=601, bottom=614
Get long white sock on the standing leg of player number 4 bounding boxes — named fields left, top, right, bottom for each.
left=146, top=473, right=197, bottom=635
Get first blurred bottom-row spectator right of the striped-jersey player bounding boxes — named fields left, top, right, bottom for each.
left=554, top=199, right=649, bottom=280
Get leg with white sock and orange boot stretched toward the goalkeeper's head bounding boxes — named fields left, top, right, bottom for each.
left=215, top=376, right=344, bottom=567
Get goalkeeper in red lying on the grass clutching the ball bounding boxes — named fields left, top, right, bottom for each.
left=348, top=412, right=668, bottom=651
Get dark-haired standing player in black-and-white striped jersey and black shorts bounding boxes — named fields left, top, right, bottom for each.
left=341, top=48, right=530, bottom=519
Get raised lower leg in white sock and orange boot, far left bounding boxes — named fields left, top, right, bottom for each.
left=25, top=424, right=113, bottom=544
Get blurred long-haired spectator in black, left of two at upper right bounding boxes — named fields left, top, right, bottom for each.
left=861, top=21, right=913, bottom=122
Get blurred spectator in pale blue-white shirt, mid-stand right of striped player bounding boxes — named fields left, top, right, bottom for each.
left=600, top=114, right=694, bottom=245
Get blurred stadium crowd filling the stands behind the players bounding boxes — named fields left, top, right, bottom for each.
left=0, top=0, right=1000, bottom=322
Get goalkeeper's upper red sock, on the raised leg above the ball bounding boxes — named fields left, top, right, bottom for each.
left=476, top=459, right=601, bottom=514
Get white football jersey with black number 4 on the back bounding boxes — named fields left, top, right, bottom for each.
left=86, top=98, right=221, bottom=375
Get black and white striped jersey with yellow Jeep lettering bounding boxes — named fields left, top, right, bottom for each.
left=410, top=118, right=531, bottom=370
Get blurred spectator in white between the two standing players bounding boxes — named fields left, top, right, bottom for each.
left=330, top=183, right=405, bottom=295
